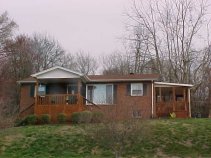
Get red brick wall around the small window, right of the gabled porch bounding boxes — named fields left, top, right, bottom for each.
left=88, top=82, right=152, bottom=120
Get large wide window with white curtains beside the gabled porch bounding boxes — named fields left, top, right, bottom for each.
left=86, top=84, right=113, bottom=104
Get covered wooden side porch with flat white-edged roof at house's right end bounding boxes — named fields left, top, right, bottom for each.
left=155, top=82, right=192, bottom=118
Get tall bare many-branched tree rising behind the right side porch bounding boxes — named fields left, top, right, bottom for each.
left=128, top=0, right=207, bottom=83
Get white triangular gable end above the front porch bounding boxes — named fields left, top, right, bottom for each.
left=31, top=67, right=82, bottom=79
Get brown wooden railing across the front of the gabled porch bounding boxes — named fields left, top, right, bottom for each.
left=37, top=94, right=83, bottom=105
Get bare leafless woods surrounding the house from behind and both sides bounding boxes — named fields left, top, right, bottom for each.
left=0, top=0, right=211, bottom=117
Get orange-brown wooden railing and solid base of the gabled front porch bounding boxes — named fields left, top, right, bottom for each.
left=34, top=94, right=86, bottom=121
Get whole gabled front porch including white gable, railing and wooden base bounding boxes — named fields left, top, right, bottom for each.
left=32, top=68, right=86, bottom=121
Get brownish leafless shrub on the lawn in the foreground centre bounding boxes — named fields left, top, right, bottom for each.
left=89, top=119, right=150, bottom=158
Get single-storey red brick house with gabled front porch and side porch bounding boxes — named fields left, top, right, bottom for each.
left=18, top=66, right=192, bottom=120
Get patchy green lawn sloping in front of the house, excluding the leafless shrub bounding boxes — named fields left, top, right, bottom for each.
left=0, top=119, right=211, bottom=158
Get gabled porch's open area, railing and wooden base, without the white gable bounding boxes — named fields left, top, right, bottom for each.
left=34, top=80, right=85, bottom=121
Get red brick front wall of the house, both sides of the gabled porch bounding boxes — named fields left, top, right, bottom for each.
left=20, top=82, right=152, bottom=120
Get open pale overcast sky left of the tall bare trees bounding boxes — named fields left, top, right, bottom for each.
left=0, top=0, right=130, bottom=56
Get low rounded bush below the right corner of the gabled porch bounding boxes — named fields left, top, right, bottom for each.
left=71, top=111, right=92, bottom=123
